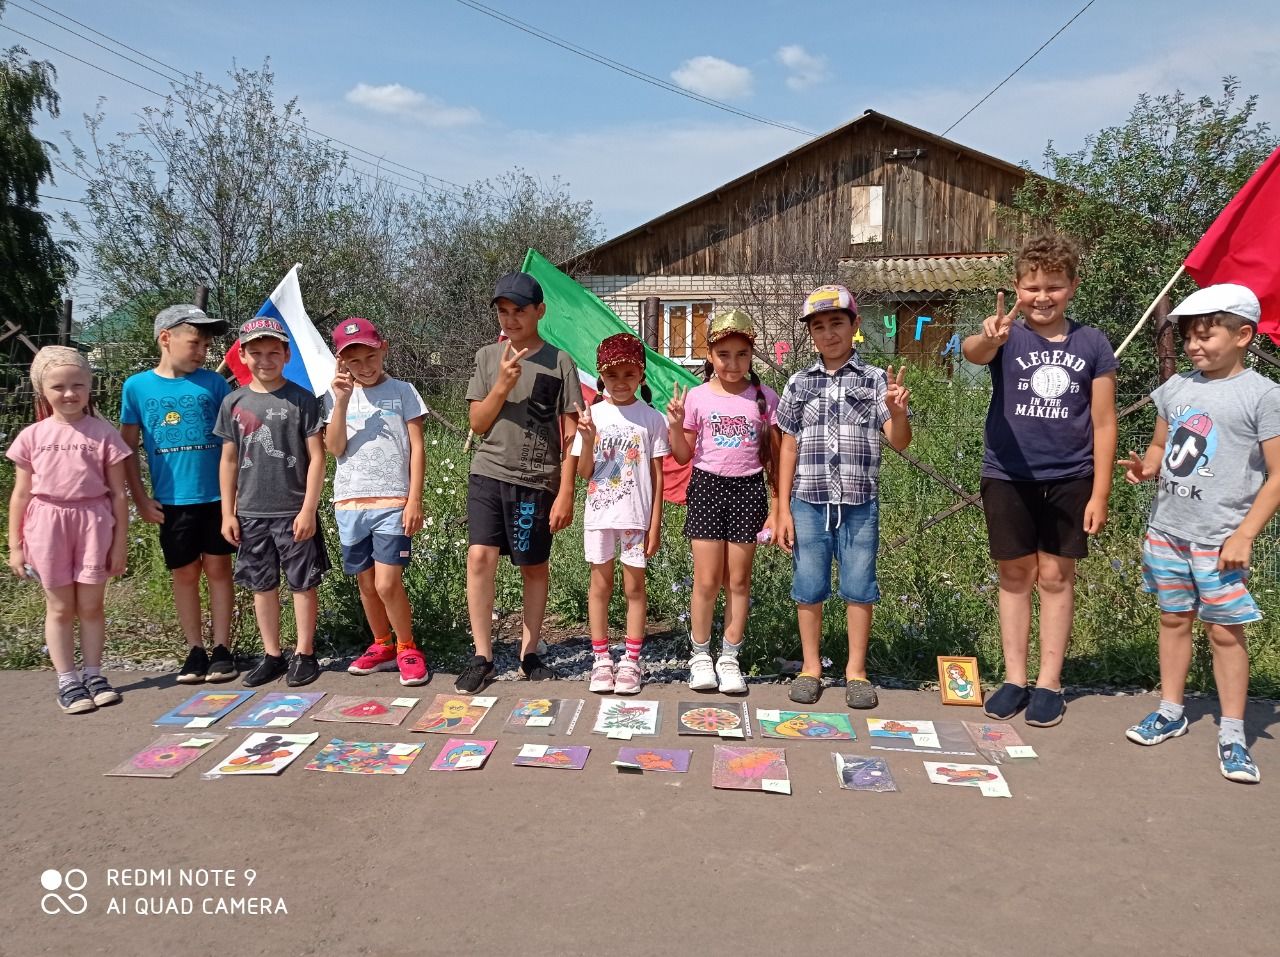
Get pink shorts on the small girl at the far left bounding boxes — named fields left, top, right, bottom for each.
left=22, top=498, right=115, bottom=589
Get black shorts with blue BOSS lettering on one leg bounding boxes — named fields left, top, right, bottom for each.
left=467, top=475, right=556, bottom=566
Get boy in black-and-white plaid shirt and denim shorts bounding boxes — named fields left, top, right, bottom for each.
left=777, top=285, right=911, bottom=708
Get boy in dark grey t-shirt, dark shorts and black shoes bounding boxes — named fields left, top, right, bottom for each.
left=214, top=316, right=329, bottom=688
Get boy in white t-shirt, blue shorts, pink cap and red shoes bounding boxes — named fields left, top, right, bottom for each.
left=324, top=316, right=430, bottom=684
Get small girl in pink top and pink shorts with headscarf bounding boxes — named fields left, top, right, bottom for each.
left=5, top=345, right=132, bottom=714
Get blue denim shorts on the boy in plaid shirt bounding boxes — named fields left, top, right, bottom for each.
left=791, top=499, right=879, bottom=605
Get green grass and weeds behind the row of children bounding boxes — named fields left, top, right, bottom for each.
left=0, top=380, right=1280, bottom=697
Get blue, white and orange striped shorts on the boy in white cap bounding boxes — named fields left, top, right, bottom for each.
left=1142, top=528, right=1262, bottom=624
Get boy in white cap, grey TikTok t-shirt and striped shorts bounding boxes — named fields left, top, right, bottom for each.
left=1120, top=284, right=1280, bottom=783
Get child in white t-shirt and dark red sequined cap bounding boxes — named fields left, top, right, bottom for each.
left=570, top=333, right=671, bottom=695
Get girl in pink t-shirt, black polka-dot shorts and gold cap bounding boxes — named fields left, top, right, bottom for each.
left=667, top=310, right=780, bottom=695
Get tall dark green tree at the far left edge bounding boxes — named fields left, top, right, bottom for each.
left=0, top=0, right=76, bottom=343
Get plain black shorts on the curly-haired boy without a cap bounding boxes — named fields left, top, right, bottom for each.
left=982, top=475, right=1093, bottom=562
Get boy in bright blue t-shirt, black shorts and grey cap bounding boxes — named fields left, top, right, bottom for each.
left=120, top=305, right=236, bottom=684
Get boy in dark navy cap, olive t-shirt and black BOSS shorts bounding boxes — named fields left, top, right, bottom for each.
left=454, top=273, right=582, bottom=695
